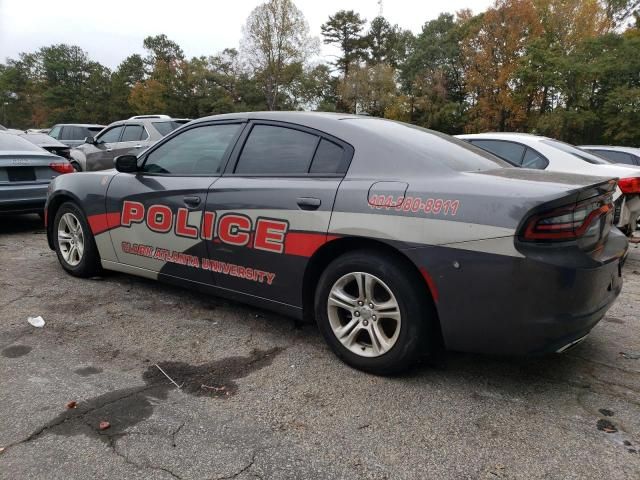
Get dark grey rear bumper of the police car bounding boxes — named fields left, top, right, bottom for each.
left=406, top=230, right=627, bottom=355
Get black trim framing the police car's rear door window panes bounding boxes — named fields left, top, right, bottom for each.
left=223, top=119, right=354, bottom=178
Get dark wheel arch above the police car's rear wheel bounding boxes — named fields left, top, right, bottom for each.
left=302, top=237, right=442, bottom=344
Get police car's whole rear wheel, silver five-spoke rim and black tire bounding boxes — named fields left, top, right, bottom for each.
left=314, top=250, right=436, bottom=375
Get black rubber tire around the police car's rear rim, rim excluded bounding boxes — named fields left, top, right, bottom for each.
left=315, top=251, right=433, bottom=375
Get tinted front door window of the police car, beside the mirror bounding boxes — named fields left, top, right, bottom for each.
left=143, top=123, right=241, bottom=175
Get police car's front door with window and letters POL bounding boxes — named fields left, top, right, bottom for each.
left=107, top=123, right=242, bottom=284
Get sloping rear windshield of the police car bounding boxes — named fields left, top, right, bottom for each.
left=342, top=118, right=513, bottom=172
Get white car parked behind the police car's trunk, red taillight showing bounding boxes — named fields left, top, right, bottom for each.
left=457, top=132, right=640, bottom=235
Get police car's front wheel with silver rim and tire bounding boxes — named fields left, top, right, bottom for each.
left=53, top=202, right=101, bottom=278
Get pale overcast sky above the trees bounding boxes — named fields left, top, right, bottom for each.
left=0, top=0, right=493, bottom=68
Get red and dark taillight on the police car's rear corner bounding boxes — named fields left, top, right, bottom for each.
left=521, top=195, right=613, bottom=242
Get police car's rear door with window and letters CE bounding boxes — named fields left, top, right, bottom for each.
left=206, top=121, right=353, bottom=306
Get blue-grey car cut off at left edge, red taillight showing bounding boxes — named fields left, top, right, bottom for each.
left=0, top=131, right=73, bottom=214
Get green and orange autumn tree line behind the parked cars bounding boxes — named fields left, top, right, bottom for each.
left=0, top=0, right=640, bottom=145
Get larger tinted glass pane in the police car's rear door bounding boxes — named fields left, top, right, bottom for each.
left=235, top=125, right=318, bottom=175
